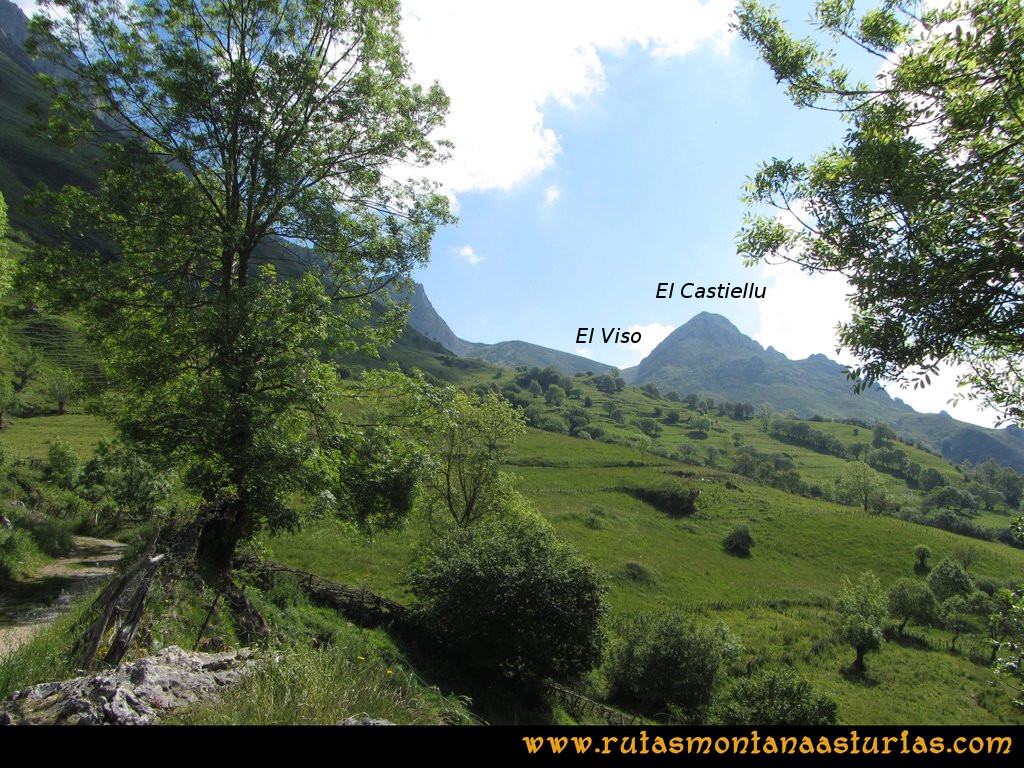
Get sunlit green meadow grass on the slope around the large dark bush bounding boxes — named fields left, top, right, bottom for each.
left=268, top=423, right=1024, bottom=723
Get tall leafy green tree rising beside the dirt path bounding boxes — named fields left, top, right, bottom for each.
left=33, top=0, right=447, bottom=575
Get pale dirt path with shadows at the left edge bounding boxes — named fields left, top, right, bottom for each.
left=0, top=536, right=125, bottom=658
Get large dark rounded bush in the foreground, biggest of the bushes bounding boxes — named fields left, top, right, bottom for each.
left=407, top=514, right=606, bottom=679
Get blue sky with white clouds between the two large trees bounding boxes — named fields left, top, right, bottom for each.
left=395, top=0, right=992, bottom=426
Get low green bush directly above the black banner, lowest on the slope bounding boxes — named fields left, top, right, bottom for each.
left=720, top=669, right=839, bottom=725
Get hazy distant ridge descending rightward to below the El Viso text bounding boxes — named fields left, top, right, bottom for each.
left=402, top=283, right=612, bottom=376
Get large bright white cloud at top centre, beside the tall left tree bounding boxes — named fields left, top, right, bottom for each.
left=401, top=0, right=734, bottom=194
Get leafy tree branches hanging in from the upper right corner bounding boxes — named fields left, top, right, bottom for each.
left=736, top=0, right=1024, bottom=422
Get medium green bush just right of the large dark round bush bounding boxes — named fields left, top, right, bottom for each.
left=604, top=611, right=739, bottom=723
